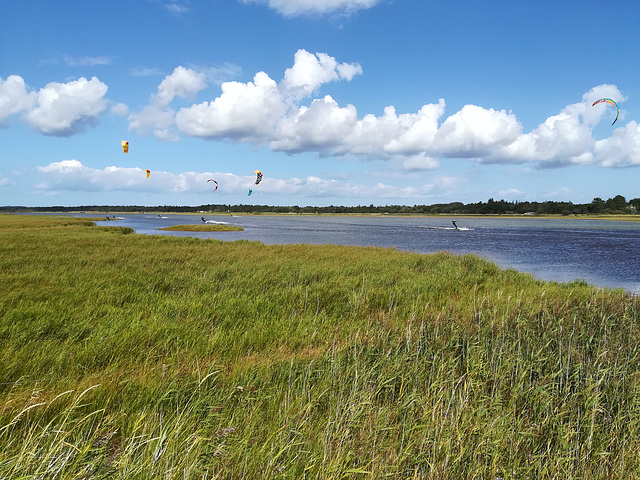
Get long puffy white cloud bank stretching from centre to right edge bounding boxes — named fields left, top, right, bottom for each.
left=162, top=50, right=637, bottom=170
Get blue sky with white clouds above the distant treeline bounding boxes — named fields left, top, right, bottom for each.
left=0, top=0, right=640, bottom=206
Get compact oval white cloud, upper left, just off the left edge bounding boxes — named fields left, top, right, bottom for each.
left=25, top=77, right=107, bottom=137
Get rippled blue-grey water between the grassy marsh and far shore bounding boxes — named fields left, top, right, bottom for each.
left=98, top=214, right=640, bottom=293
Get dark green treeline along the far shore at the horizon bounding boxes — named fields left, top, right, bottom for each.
left=0, top=195, right=640, bottom=215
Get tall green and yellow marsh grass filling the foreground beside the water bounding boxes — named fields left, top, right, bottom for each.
left=0, top=216, right=640, bottom=479
